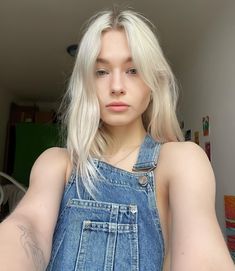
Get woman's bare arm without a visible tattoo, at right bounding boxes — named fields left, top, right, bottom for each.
left=167, top=142, right=235, bottom=271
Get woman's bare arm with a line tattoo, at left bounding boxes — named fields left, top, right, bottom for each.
left=0, top=148, right=68, bottom=271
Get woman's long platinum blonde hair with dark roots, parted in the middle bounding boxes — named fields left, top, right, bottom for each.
left=61, top=9, right=183, bottom=195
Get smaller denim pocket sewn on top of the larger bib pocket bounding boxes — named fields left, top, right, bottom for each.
left=74, top=220, right=139, bottom=271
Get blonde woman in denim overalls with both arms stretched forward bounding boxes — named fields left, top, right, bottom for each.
left=0, top=7, right=234, bottom=271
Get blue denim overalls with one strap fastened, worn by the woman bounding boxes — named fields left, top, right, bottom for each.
left=47, top=134, right=164, bottom=271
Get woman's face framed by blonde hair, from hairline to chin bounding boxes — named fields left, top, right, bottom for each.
left=95, top=30, right=150, bottom=129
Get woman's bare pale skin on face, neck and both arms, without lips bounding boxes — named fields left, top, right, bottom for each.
left=0, top=30, right=235, bottom=271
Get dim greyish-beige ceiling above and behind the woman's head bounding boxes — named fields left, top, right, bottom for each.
left=0, top=0, right=225, bottom=102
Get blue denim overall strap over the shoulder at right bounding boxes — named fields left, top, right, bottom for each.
left=132, top=134, right=161, bottom=171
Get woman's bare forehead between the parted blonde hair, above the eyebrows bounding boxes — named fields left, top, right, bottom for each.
left=98, top=29, right=131, bottom=59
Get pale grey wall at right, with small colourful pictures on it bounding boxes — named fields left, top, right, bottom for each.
left=179, top=1, right=235, bottom=235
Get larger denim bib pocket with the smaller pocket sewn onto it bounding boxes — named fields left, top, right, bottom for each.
left=48, top=199, right=139, bottom=271
